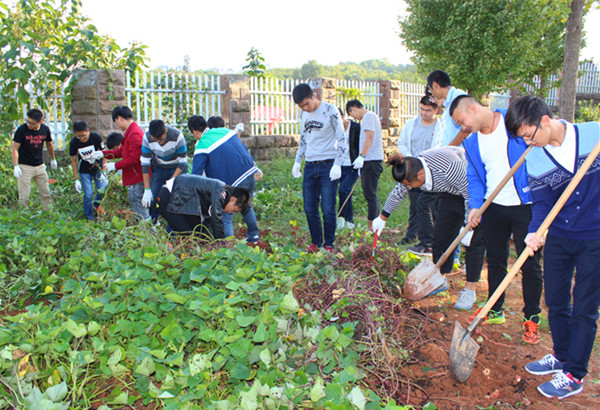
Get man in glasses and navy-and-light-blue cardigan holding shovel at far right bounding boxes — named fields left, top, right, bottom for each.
left=506, top=95, right=600, bottom=399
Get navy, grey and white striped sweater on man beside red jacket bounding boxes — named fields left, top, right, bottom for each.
left=140, top=127, right=188, bottom=174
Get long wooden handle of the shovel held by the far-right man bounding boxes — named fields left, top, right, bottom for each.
left=468, top=141, right=600, bottom=333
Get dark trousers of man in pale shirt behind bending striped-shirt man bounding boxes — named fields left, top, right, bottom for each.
left=405, top=189, right=436, bottom=247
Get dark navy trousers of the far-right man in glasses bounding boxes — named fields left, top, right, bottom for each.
left=544, top=234, right=600, bottom=379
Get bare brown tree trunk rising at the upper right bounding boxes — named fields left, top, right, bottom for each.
left=558, top=0, right=591, bottom=122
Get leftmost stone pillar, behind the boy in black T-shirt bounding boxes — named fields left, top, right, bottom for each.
left=71, top=70, right=125, bottom=138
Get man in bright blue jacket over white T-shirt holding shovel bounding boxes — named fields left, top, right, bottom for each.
left=450, top=95, right=542, bottom=344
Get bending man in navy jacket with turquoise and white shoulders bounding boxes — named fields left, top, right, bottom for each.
left=188, top=115, right=262, bottom=244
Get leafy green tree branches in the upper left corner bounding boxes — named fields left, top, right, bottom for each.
left=0, top=0, right=146, bottom=135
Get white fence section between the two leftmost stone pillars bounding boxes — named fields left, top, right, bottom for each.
left=125, top=71, right=225, bottom=130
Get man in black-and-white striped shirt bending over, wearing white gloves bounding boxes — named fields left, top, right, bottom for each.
left=373, top=146, right=485, bottom=296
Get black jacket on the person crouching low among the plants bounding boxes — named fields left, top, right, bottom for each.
left=167, top=174, right=231, bottom=239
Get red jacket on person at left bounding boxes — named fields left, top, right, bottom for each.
left=103, top=122, right=144, bottom=186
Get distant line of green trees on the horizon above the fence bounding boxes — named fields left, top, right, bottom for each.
left=267, top=59, right=424, bottom=82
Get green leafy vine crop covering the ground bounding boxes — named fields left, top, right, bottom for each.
left=0, top=144, right=408, bottom=409
